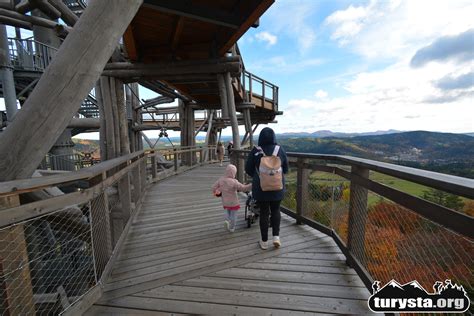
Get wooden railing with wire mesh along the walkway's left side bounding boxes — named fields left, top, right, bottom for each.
left=0, top=147, right=215, bottom=315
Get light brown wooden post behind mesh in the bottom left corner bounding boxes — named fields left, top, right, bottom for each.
left=0, top=195, right=35, bottom=315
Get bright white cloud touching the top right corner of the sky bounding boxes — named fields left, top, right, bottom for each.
left=325, top=0, right=474, bottom=59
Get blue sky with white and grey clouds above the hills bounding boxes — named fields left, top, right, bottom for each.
left=1, top=0, right=474, bottom=137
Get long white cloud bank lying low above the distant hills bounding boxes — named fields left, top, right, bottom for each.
left=278, top=58, right=474, bottom=133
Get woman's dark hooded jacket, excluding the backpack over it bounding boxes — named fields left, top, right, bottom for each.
left=245, top=127, right=288, bottom=201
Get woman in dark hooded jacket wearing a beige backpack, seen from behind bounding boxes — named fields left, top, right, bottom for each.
left=245, top=127, right=288, bottom=250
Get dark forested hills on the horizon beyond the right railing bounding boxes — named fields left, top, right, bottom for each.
left=279, top=131, right=474, bottom=178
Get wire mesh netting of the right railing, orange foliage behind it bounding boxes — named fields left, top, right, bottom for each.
left=282, top=166, right=474, bottom=306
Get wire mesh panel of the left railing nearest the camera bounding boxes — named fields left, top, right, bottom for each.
left=0, top=204, right=96, bottom=315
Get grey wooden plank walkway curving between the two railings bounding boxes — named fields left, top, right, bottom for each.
left=86, top=165, right=369, bottom=315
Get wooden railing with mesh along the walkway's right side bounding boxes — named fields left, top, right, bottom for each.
left=233, top=150, right=474, bottom=294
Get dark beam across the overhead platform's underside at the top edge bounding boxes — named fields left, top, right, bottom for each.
left=143, top=0, right=241, bottom=29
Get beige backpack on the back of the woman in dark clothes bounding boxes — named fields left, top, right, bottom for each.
left=257, top=145, right=283, bottom=191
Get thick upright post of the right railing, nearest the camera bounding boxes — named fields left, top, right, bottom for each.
left=347, top=166, right=369, bottom=265
